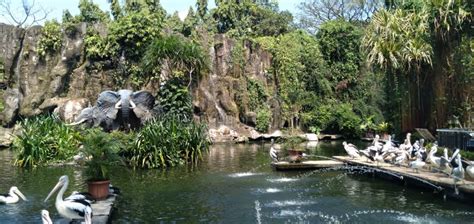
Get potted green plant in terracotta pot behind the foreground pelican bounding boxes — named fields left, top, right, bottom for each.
left=82, top=128, right=120, bottom=200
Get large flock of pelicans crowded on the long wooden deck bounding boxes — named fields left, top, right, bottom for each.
left=342, top=133, right=474, bottom=181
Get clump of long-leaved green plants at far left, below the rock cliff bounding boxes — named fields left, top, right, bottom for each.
left=12, top=116, right=80, bottom=167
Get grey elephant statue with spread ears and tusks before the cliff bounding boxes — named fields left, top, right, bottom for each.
left=70, top=89, right=159, bottom=131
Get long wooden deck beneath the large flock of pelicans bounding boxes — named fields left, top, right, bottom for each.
left=333, top=156, right=474, bottom=197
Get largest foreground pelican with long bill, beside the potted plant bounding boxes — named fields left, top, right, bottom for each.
left=44, top=175, right=92, bottom=224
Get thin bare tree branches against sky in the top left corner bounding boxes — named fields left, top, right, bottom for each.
left=0, top=0, right=50, bottom=28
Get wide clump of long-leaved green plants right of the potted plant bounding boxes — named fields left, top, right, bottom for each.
left=122, top=116, right=209, bottom=169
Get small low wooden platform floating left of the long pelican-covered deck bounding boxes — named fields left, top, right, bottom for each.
left=272, top=160, right=344, bottom=170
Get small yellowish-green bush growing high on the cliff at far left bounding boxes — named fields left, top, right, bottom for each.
left=36, top=20, right=63, bottom=57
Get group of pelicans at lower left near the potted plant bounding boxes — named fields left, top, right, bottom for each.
left=0, top=175, right=118, bottom=224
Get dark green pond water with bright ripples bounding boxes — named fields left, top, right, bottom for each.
left=0, top=141, right=474, bottom=223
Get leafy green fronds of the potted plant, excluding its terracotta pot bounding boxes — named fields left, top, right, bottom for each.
left=82, top=128, right=122, bottom=181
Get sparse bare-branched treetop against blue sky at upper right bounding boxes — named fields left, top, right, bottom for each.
left=298, top=0, right=383, bottom=33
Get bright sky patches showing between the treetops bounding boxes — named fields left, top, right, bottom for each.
left=0, top=0, right=303, bottom=23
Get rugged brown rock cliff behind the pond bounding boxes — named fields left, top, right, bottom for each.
left=0, top=23, right=281, bottom=144
